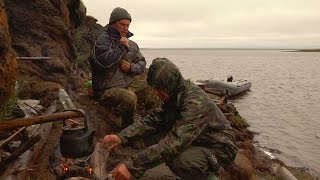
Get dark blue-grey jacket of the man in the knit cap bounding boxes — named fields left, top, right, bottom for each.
left=90, top=25, right=146, bottom=97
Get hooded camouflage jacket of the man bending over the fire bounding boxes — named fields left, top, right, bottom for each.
left=118, top=59, right=237, bottom=174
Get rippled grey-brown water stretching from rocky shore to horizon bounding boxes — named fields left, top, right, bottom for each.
left=141, top=49, right=320, bottom=175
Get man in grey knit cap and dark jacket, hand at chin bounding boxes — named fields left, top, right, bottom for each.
left=90, top=7, right=146, bottom=127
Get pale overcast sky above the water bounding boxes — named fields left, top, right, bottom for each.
left=82, top=0, right=320, bottom=49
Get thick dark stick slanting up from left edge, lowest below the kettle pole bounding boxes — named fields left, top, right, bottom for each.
left=0, top=134, right=41, bottom=170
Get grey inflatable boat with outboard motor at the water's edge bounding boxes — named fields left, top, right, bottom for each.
left=196, top=76, right=252, bottom=96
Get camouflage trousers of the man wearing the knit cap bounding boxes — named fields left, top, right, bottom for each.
left=99, top=79, right=158, bottom=128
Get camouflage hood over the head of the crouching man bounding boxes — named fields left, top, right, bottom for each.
left=147, top=58, right=184, bottom=96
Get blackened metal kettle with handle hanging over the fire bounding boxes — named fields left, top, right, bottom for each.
left=60, top=110, right=96, bottom=158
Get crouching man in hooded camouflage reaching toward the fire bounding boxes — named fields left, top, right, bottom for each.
left=103, top=58, right=237, bottom=180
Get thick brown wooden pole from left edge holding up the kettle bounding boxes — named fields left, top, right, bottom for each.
left=0, top=111, right=83, bottom=130
